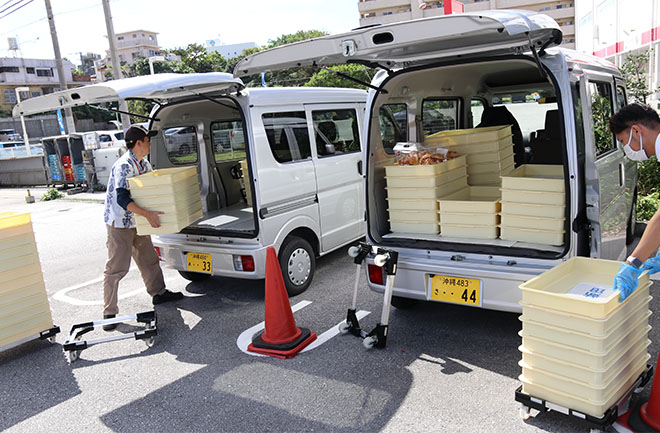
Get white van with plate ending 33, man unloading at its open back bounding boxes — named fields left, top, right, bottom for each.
left=15, top=73, right=367, bottom=295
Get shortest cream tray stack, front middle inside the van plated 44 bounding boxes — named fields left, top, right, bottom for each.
left=438, top=186, right=500, bottom=239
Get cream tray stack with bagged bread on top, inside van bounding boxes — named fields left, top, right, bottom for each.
left=385, top=156, right=467, bottom=234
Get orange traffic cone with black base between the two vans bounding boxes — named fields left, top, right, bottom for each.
left=248, top=247, right=316, bottom=358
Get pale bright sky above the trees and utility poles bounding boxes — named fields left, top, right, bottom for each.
left=0, top=0, right=360, bottom=64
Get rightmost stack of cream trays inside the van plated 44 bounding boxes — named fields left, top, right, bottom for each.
left=500, top=165, right=566, bottom=245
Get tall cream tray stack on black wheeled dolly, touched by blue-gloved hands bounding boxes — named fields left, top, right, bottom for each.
left=516, top=257, right=652, bottom=431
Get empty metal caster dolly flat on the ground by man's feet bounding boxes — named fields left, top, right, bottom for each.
left=63, top=311, right=158, bottom=362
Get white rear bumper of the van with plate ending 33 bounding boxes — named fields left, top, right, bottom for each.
left=153, top=238, right=267, bottom=280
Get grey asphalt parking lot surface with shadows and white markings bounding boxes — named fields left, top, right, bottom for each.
left=0, top=189, right=660, bottom=433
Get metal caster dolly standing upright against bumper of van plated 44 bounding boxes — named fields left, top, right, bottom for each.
left=339, top=242, right=399, bottom=349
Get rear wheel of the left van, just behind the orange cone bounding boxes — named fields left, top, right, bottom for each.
left=279, top=236, right=316, bottom=296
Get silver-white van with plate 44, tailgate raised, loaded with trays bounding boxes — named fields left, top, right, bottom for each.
left=234, top=11, right=637, bottom=312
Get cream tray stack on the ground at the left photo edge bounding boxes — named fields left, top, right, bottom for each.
left=0, top=212, right=53, bottom=348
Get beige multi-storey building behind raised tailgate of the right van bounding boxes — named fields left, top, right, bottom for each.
left=358, top=0, right=577, bottom=48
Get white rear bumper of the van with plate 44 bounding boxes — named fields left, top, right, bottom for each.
left=365, top=255, right=555, bottom=313
